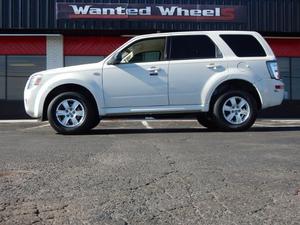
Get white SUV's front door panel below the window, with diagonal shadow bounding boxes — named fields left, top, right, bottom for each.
left=103, top=61, right=169, bottom=107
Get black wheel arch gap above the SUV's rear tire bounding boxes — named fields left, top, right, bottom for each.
left=208, top=79, right=262, bottom=110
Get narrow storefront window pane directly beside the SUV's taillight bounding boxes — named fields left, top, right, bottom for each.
left=277, top=57, right=291, bottom=99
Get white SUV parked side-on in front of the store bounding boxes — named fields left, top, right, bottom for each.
left=24, top=31, right=284, bottom=134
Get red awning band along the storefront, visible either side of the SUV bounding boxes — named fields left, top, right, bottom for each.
left=0, top=36, right=300, bottom=57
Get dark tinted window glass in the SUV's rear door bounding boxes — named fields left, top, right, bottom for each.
left=170, top=35, right=222, bottom=60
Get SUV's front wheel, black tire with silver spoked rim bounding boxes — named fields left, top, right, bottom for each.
left=47, top=92, right=99, bottom=134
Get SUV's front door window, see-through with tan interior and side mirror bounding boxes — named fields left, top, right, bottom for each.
left=120, top=38, right=165, bottom=64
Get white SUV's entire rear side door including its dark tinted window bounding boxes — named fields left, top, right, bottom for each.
left=169, top=35, right=227, bottom=105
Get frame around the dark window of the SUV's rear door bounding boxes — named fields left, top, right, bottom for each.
left=167, top=34, right=224, bottom=61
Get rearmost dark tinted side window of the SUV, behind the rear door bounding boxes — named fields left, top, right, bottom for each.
left=220, top=34, right=266, bottom=57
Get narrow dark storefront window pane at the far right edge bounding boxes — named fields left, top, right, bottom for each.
left=291, top=58, right=300, bottom=100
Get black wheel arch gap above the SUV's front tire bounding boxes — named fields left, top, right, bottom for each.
left=41, top=83, right=99, bottom=121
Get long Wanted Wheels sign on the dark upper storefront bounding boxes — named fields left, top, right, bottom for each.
left=56, top=3, right=247, bottom=23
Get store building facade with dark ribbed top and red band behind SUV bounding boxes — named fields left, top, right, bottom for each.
left=0, top=0, right=300, bottom=118
